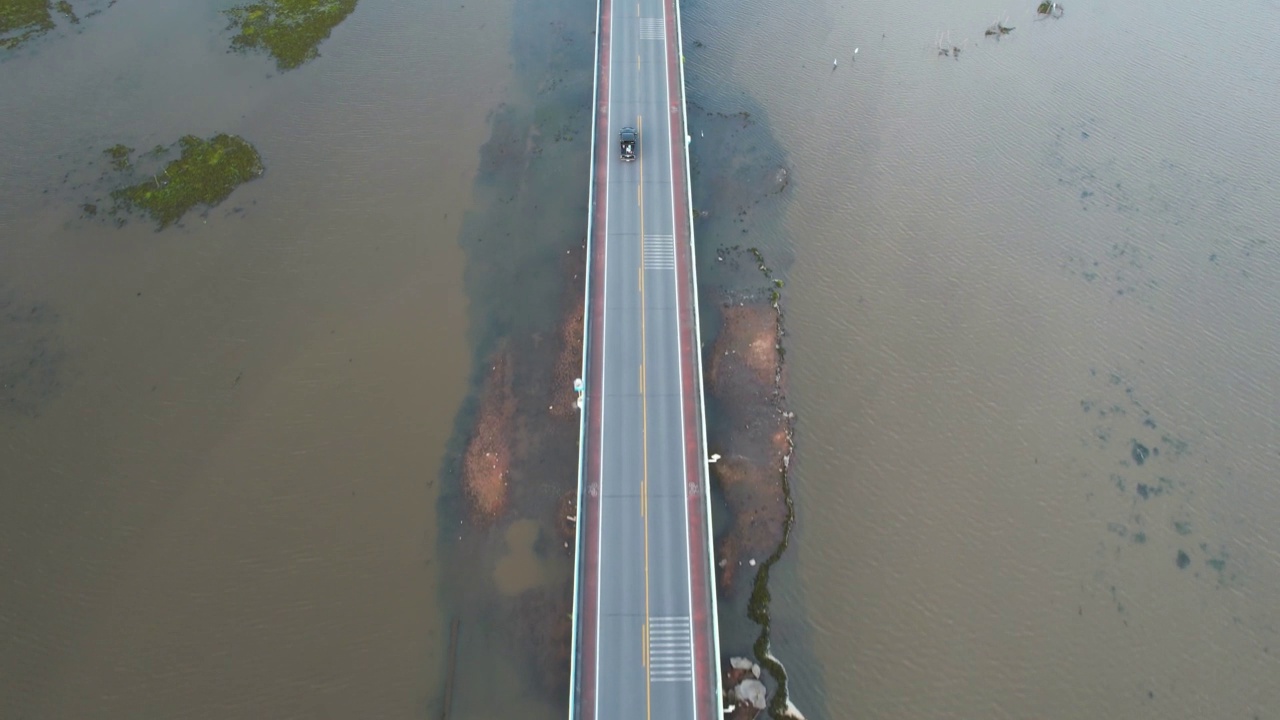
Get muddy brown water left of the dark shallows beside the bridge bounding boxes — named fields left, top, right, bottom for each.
left=0, top=1, right=509, bottom=719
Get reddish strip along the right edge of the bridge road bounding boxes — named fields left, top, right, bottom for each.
left=663, top=0, right=719, bottom=720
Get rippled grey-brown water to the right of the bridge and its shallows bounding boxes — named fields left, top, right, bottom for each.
left=686, top=1, right=1280, bottom=717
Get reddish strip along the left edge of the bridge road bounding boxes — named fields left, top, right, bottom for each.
left=570, top=0, right=613, bottom=720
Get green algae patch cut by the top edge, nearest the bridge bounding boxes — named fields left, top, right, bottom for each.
left=225, top=0, right=358, bottom=70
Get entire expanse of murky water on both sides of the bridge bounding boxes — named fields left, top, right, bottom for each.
left=0, top=0, right=1280, bottom=719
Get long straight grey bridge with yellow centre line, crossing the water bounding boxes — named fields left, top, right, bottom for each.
left=570, top=0, right=721, bottom=720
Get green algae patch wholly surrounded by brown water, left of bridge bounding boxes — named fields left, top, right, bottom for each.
left=106, top=133, right=262, bottom=229
